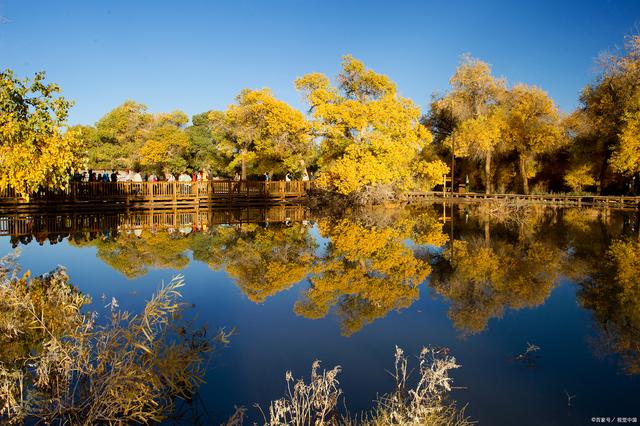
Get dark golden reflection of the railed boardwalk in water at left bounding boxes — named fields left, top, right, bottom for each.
left=0, top=205, right=309, bottom=241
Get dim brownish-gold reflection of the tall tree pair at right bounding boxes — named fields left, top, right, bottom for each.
left=431, top=216, right=566, bottom=334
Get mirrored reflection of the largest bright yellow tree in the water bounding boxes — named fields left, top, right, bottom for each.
left=294, top=212, right=446, bottom=336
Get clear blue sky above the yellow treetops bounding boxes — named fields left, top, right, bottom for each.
left=0, top=0, right=640, bottom=124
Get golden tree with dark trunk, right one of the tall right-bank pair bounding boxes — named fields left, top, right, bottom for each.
left=504, top=84, right=566, bottom=194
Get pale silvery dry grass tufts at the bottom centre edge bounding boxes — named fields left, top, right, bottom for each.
left=252, top=347, right=473, bottom=426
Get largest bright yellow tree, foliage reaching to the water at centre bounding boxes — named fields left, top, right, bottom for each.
left=296, top=55, right=431, bottom=195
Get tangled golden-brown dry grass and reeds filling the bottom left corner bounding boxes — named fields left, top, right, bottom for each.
left=0, top=255, right=226, bottom=424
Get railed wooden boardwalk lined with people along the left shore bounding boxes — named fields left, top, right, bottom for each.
left=0, top=180, right=313, bottom=207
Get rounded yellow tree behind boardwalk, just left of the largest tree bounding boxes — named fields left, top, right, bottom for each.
left=209, top=89, right=313, bottom=180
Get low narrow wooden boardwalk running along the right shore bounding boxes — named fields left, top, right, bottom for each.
left=407, top=191, right=640, bottom=210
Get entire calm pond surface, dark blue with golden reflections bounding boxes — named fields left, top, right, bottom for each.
left=0, top=205, right=640, bottom=425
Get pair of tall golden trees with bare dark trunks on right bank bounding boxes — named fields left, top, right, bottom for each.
left=424, top=56, right=564, bottom=194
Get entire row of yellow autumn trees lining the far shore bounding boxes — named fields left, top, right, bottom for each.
left=5, top=36, right=640, bottom=197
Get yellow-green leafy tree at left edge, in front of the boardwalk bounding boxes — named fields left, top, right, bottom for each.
left=0, top=70, right=82, bottom=198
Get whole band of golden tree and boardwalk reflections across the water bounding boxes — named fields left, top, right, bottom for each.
left=0, top=205, right=640, bottom=374
